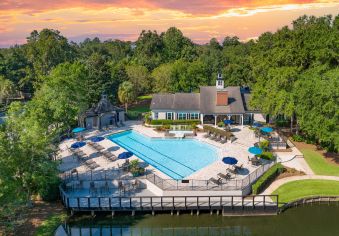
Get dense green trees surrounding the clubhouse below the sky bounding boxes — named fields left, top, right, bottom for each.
left=0, top=12, right=339, bottom=230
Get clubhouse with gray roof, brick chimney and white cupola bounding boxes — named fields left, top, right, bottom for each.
left=151, top=74, right=259, bottom=125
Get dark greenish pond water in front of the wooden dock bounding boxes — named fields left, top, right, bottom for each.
left=55, top=204, right=339, bottom=236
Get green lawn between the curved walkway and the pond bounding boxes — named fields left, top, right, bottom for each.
left=273, top=180, right=339, bottom=203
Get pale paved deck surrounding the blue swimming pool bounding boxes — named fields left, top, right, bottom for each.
left=58, top=121, right=308, bottom=195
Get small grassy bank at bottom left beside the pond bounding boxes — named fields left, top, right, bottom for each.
left=35, top=213, right=67, bottom=236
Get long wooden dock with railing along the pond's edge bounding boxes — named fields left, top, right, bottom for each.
left=60, top=186, right=279, bottom=216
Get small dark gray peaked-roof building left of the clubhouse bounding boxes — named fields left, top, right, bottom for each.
left=79, top=95, right=125, bottom=129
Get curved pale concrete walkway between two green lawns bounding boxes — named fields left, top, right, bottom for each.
left=261, top=175, right=339, bottom=195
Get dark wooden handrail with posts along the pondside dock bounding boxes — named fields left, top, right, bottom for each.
left=60, top=186, right=279, bottom=210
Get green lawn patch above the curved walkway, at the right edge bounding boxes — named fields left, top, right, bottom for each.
left=301, top=148, right=339, bottom=176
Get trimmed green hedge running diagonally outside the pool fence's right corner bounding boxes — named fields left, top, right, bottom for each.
left=252, top=163, right=284, bottom=194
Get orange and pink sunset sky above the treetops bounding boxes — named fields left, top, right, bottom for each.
left=0, top=0, right=339, bottom=47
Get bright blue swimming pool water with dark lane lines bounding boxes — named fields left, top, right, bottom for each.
left=108, top=131, right=217, bottom=179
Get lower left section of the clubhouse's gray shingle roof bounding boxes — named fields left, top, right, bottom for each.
left=151, top=93, right=200, bottom=111
